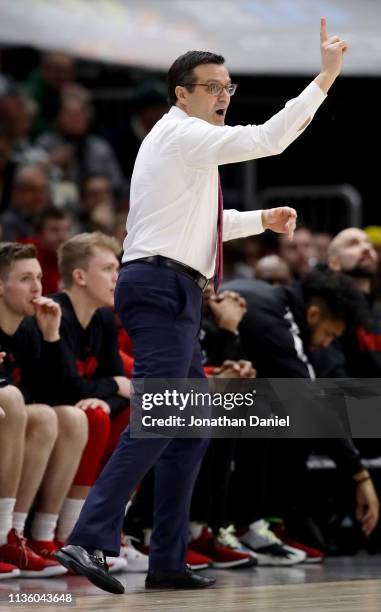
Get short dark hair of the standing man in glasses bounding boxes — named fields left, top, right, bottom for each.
left=167, top=51, right=225, bottom=104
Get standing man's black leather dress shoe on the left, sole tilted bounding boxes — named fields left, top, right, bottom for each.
left=54, top=544, right=124, bottom=595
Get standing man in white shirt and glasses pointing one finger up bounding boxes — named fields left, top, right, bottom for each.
left=57, top=19, right=346, bottom=593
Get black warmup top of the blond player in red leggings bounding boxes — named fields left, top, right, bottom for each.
left=47, top=292, right=128, bottom=414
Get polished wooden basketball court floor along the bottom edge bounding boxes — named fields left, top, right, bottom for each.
left=0, top=555, right=381, bottom=612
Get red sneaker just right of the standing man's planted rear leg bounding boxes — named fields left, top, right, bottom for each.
left=189, top=527, right=256, bottom=568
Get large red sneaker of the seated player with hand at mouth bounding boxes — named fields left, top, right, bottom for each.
left=0, top=529, right=67, bottom=578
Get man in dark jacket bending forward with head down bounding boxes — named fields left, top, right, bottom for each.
left=225, top=271, right=379, bottom=560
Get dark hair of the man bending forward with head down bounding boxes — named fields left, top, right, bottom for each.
left=302, top=270, right=366, bottom=326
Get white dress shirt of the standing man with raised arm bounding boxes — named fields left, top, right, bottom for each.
left=123, top=82, right=326, bottom=278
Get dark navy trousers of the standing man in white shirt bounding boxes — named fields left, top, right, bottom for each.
left=68, top=262, right=209, bottom=570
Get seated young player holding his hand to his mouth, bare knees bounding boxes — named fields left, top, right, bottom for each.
left=0, top=243, right=87, bottom=577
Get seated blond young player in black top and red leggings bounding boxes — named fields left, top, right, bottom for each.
left=49, top=232, right=147, bottom=571
